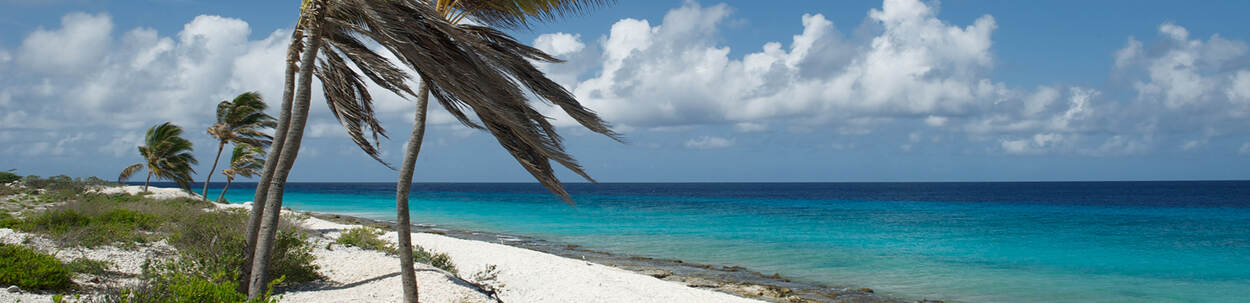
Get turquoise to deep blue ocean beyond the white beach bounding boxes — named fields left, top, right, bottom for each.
left=187, top=182, right=1250, bottom=302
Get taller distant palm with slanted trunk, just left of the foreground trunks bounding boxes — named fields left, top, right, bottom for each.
left=201, top=91, right=278, bottom=200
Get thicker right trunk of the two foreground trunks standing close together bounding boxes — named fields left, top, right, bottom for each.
left=248, top=0, right=326, bottom=299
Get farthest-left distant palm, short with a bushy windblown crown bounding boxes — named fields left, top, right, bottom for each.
left=118, top=121, right=199, bottom=192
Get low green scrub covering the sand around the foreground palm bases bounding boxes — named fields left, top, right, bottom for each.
left=0, top=177, right=323, bottom=302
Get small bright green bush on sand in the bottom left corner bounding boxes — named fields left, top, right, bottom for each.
left=0, top=244, right=74, bottom=290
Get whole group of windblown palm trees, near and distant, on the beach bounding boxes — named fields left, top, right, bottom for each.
left=123, top=0, right=620, bottom=302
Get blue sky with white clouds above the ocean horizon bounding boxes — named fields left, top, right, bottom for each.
left=0, top=0, right=1250, bottom=182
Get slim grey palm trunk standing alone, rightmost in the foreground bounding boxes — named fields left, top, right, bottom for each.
left=395, top=84, right=430, bottom=303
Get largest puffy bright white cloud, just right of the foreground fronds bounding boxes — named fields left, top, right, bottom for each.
left=535, top=0, right=1005, bottom=126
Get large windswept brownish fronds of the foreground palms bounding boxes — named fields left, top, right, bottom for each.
left=313, top=0, right=620, bottom=202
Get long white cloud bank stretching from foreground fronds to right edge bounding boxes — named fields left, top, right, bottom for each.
left=525, top=0, right=1250, bottom=155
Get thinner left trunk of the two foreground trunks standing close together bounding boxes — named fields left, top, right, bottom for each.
left=239, top=21, right=304, bottom=293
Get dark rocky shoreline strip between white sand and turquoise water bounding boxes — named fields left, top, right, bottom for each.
left=305, top=210, right=920, bottom=303
